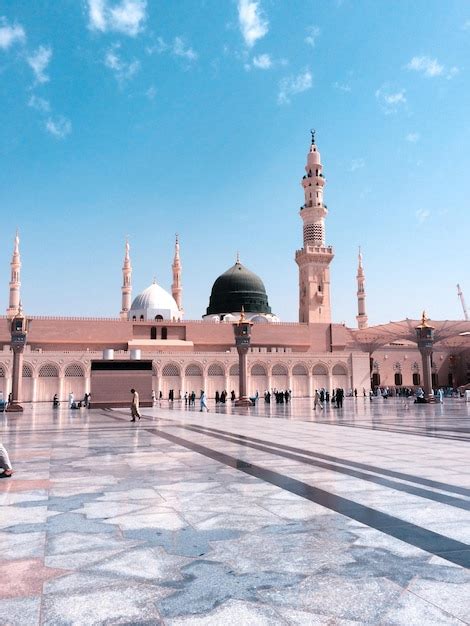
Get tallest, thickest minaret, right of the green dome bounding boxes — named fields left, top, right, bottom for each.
left=295, top=130, right=334, bottom=324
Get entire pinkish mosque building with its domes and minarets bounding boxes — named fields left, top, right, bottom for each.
left=0, top=133, right=470, bottom=402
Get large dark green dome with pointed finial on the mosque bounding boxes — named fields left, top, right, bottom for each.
left=206, top=261, right=271, bottom=315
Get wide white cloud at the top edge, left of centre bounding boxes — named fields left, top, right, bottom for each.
left=88, top=0, right=147, bottom=37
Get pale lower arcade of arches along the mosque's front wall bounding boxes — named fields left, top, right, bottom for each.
left=0, top=346, right=369, bottom=402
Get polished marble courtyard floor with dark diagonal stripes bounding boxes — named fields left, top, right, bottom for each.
left=0, top=398, right=470, bottom=626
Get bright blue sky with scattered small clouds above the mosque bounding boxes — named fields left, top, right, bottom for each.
left=0, top=0, right=470, bottom=325
